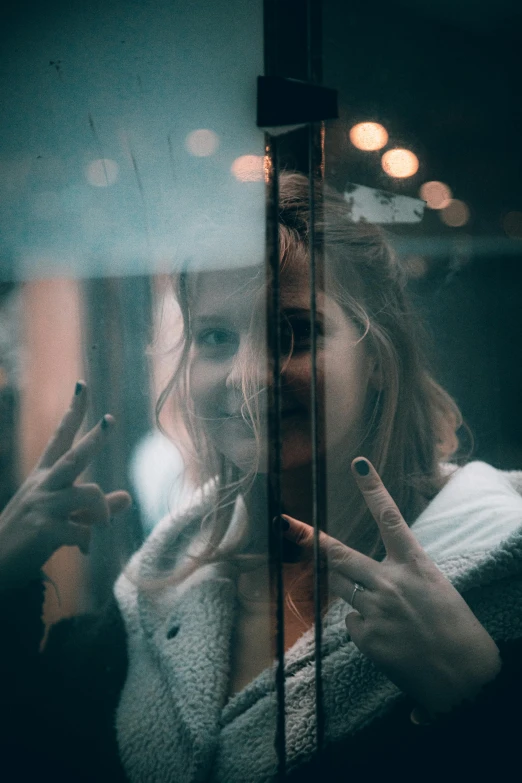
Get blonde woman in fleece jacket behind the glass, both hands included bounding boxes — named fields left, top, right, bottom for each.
left=0, top=175, right=522, bottom=781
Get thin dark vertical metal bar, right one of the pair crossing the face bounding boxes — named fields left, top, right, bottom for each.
left=307, top=0, right=325, bottom=768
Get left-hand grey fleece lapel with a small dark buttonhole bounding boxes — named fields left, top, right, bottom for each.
left=116, top=566, right=235, bottom=783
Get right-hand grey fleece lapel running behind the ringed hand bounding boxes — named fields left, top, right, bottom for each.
left=212, top=531, right=522, bottom=783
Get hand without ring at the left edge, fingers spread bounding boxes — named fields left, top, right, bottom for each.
left=0, top=382, right=131, bottom=587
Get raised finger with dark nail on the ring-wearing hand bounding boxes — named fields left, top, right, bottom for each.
left=352, top=457, right=418, bottom=560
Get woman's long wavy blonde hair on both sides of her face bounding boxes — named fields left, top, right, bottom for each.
left=152, top=173, right=462, bottom=568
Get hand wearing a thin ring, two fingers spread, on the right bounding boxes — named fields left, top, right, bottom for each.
left=284, top=458, right=501, bottom=714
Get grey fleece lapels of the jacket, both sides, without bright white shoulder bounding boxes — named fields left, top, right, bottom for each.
left=117, top=468, right=522, bottom=783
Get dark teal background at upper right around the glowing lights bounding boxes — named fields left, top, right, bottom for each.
left=278, top=0, right=522, bottom=468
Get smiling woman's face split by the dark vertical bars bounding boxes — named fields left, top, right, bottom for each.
left=190, top=262, right=373, bottom=472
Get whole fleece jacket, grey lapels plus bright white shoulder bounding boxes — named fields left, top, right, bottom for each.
left=116, top=462, right=522, bottom=783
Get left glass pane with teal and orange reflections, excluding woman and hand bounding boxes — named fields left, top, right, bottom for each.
left=0, top=0, right=265, bottom=621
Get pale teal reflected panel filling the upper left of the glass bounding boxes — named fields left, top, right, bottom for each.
left=0, top=0, right=264, bottom=280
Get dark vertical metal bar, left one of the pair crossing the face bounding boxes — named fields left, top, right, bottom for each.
left=264, top=0, right=286, bottom=781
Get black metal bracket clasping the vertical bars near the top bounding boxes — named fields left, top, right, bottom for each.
left=257, top=76, right=339, bottom=128
